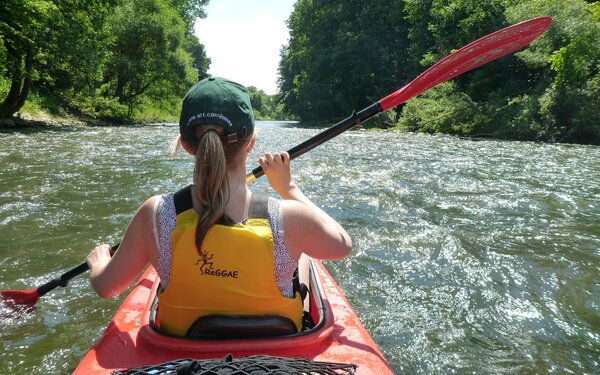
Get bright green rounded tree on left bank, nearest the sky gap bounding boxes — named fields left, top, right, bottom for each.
left=106, top=0, right=196, bottom=109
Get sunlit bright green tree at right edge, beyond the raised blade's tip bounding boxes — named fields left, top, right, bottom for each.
left=507, top=0, right=600, bottom=144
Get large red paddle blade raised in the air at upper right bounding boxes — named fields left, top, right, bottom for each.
left=379, top=17, right=552, bottom=111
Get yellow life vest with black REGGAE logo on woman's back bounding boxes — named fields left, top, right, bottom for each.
left=158, top=186, right=302, bottom=336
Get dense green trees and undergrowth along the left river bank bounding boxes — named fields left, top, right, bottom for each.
left=0, top=0, right=210, bottom=120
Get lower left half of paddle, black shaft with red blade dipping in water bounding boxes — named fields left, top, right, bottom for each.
left=0, top=244, right=119, bottom=307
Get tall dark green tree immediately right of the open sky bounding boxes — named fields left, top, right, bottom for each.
left=279, top=0, right=408, bottom=121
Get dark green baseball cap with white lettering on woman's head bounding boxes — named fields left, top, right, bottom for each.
left=179, top=77, right=254, bottom=143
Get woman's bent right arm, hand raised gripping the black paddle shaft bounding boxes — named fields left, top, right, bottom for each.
left=259, top=152, right=352, bottom=260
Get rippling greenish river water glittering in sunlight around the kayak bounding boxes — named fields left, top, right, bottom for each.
left=0, top=122, right=600, bottom=374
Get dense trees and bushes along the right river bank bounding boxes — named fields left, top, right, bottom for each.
left=279, top=0, right=600, bottom=144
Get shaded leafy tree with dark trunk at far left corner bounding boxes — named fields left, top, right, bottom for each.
left=0, top=0, right=113, bottom=118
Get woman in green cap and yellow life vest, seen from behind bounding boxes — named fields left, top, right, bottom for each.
left=87, top=77, right=352, bottom=336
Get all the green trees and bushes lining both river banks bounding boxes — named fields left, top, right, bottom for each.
left=0, top=0, right=600, bottom=144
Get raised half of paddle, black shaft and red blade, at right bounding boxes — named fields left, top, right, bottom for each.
left=246, top=17, right=552, bottom=184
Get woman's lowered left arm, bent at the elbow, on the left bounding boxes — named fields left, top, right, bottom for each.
left=86, top=196, right=160, bottom=298
